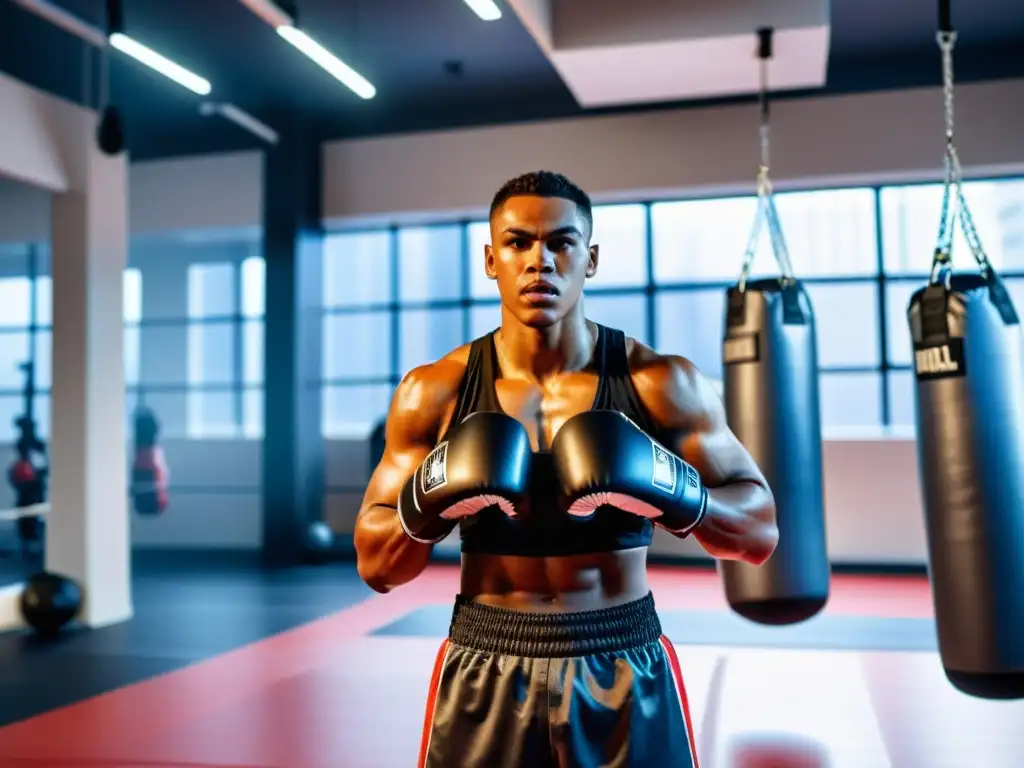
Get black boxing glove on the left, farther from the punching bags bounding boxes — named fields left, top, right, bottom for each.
left=398, top=412, right=532, bottom=544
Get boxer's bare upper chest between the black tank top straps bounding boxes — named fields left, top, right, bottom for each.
left=495, top=371, right=600, bottom=451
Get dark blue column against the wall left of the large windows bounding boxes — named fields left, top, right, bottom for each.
left=262, top=118, right=324, bottom=566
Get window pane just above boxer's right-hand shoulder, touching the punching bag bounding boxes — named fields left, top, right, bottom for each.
left=654, top=288, right=725, bottom=379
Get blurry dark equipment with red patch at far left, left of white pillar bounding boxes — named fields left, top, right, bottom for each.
left=7, top=362, right=49, bottom=555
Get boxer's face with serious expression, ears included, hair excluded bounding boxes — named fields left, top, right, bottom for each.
left=485, top=196, right=597, bottom=328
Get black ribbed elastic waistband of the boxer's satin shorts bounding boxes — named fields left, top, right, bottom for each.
left=449, top=593, right=662, bottom=658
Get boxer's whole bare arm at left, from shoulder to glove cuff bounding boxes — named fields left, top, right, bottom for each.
left=354, top=358, right=465, bottom=592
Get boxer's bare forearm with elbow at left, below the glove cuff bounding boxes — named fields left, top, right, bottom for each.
left=354, top=505, right=433, bottom=593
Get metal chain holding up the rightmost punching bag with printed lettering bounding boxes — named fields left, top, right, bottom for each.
left=931, top=31, right=991, bottom=287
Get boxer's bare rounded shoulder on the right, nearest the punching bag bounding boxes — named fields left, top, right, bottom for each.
left=626, top=338, right=725, bottom=431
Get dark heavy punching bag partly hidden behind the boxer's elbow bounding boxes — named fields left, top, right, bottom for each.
left=720, top=279, right=830, bottom=625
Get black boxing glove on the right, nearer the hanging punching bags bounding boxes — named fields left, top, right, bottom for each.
left=551, top=411, right=708, bottom=536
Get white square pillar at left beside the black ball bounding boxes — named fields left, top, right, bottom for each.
left=46, top=131, right=132, bottom=627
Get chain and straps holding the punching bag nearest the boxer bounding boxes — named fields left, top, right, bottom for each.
left=737, top=28, right=796, bottom=293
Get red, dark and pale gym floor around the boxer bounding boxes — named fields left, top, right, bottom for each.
left=0, top=555, right=1024, bottom=768
